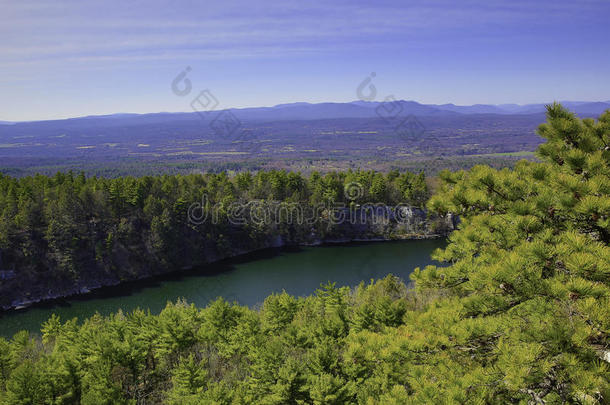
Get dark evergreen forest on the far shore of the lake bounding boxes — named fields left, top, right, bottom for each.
left=0, top=171, right=428, bottom=306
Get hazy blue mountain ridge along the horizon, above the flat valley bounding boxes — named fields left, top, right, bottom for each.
left=0, top=100, right=610, bottom=125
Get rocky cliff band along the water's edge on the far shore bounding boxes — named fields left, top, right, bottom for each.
left=0, top=205, right=457, bottom=310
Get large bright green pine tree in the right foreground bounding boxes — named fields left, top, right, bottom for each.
left=411, top=104, right=610, bottom=403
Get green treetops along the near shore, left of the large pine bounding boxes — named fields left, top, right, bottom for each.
left=0, top=276, right=427, bottom=405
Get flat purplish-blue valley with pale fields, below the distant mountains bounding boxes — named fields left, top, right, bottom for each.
left=0, top=110, right=543, bottom=177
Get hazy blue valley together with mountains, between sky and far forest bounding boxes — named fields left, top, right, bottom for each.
left=0, top=100, right=610, bottom=174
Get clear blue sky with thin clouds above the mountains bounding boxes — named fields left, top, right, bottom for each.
left=0, top=0, right=610, bottom=120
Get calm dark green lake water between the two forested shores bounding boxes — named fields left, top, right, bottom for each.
left=0, top=240, right=445, bottom=337
